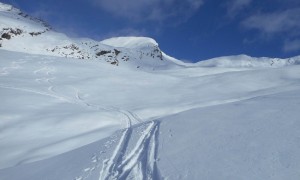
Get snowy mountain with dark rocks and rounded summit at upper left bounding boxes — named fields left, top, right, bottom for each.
left=0, top=3, right=177, bottom=70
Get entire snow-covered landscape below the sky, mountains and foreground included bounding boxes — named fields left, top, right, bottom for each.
left=0, top=3, right=300, bottom=180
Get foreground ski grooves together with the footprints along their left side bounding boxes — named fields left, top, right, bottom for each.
left=74, top=121, right=163, bottom=180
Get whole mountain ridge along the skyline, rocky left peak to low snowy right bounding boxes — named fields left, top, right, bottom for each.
left=0, top=3, right=300, bottom=70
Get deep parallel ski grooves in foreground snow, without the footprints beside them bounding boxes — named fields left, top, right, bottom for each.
left=99, top=121, right=162, bottom=180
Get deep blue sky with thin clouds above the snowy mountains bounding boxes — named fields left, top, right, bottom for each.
left=2, top=0, right=300, bottom=61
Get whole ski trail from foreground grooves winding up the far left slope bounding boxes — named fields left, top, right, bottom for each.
left=28, top=58, right=157, bottom=180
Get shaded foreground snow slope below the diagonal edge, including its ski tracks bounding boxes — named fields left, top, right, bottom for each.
left=0, top=89, right=300, bottom=180
